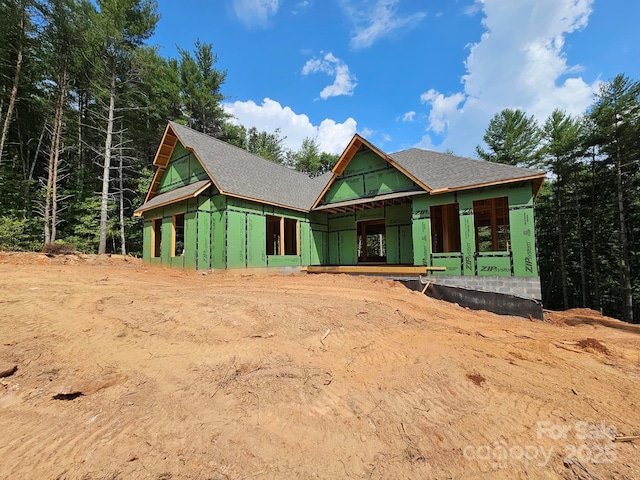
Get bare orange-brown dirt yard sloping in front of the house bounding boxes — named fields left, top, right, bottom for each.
left=0, top=253, right=640, bottom=480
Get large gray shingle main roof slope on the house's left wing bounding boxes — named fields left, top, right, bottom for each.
left=170, top=122, right=330, bottom=211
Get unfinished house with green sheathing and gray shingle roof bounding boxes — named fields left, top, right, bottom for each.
left=135, top=122, right=545, bottom=316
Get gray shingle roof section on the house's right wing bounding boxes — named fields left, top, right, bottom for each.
left=389, top=148, right=545, bottom=190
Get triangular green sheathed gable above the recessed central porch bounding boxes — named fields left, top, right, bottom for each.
left=322, top=150, right=420, bottom=204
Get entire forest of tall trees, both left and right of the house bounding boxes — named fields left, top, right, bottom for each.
left=0, top=0, right=640, bottom=321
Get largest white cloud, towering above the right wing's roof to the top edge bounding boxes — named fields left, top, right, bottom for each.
left=420, top=0, right=599, bottom=155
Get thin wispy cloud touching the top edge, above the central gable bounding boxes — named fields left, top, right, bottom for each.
left=341, top=0, right=426, bottom=50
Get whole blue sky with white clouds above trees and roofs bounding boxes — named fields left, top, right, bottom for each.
left=150, top=0, right=640, bottom=157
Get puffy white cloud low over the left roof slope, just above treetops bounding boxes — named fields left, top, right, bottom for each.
left=224, top=98, right=357, bottom=154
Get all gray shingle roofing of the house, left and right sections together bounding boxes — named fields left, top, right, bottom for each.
left=156, top=122, right=545, bottom=211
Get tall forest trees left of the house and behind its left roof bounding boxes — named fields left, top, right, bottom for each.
left=0, top=0, right=337, bottom=254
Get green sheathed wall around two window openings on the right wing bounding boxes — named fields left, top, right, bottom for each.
left=412, top=182, right=538, bottom=277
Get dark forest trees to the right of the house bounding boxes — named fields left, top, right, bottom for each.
left=476, top=75, right=640, bottom=322
